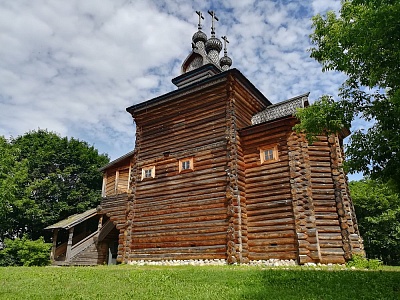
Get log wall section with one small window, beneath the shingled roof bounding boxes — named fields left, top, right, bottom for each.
left=241, top=121, right=297, bottom=260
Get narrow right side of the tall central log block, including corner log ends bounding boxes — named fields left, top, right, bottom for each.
left=226, top=76, right=266, bottom=263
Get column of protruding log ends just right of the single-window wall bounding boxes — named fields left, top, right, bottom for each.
left=288, top=133, right=321, bottom=264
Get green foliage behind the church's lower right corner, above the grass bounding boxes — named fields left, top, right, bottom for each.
left=350, top=180, right=400, bottom=265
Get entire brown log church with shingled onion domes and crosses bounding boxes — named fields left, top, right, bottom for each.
left=47, top=12, right=363, bottom=265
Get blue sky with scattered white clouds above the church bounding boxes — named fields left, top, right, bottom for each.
left=0, top=0, right=362, bottom=179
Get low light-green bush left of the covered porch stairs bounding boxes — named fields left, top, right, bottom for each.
left=0, top=236, right=51, bottom=266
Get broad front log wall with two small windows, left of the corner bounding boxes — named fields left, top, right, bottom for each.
left=129, top=83, right=228, bottom=260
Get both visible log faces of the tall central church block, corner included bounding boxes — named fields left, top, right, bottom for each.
left=125, top=77, right=264, bottom=263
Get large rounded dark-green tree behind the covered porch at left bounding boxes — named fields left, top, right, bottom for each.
left=0, top=130, right=109, bottom=241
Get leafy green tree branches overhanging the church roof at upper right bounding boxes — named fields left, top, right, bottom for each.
left=296, top=0, right=400, bottom=190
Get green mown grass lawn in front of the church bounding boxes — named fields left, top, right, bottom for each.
left=0, top=265, right=400, bottom=300
